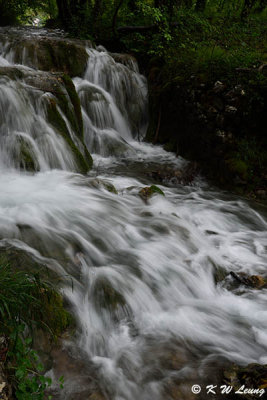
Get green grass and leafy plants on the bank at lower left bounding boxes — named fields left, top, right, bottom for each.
left=0, top=258, right=72, bottom=400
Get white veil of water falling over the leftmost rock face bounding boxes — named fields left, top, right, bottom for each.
left=0, top=72, right=76, bottom=171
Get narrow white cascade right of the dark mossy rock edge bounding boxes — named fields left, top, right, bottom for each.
left=74, top=46, right=147, bottom=156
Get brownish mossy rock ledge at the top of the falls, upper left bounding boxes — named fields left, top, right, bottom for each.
left=0, top=29, right=88, bottom=77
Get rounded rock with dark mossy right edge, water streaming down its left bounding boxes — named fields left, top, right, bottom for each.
left=0, top=66, right=92, bottom=173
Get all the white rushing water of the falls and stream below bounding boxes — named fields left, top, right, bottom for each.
left=0, top=27, right=267, bottom=400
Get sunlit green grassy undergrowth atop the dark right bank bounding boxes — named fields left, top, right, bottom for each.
left=144, top=9, right=267, bottom=83
